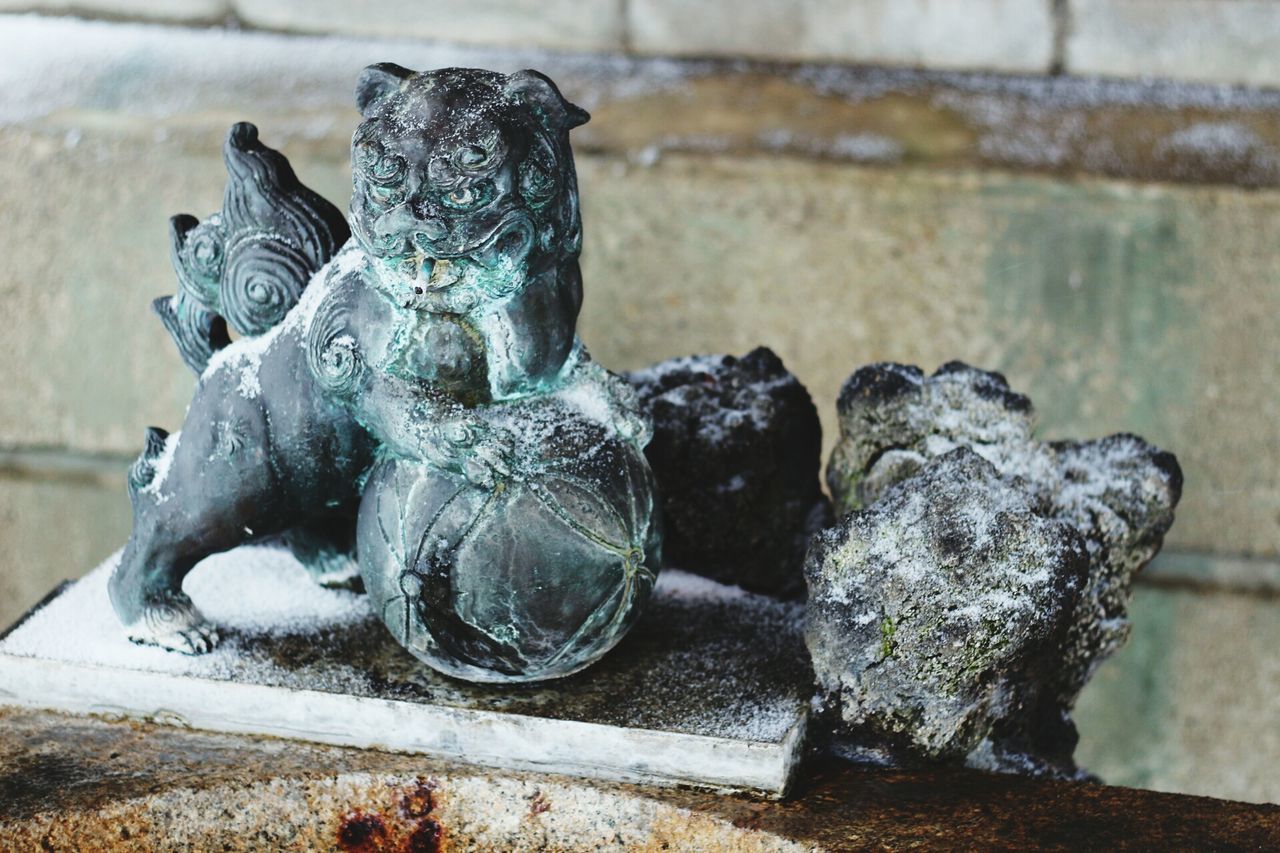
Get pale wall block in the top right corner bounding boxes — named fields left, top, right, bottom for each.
left=1065, top=0, right=1280, bottom=86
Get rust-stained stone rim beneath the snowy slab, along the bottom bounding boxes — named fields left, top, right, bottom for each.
left=0, top=711, right=1280, bottom=850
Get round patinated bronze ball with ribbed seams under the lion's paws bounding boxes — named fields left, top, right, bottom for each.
left=358, top=422, right=660, bottom=683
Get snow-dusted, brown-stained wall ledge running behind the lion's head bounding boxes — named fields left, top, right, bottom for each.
left=0, top=15, right=1280, bottom=187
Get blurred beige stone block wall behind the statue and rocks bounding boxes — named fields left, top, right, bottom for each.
left=0, top=0, right=1280, bottom=799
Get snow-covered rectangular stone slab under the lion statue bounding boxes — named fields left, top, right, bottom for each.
left=0, top=547, right=812, bottom=795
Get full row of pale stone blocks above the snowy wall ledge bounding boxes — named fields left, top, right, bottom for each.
left=0, top=0, right=1280, bottom=87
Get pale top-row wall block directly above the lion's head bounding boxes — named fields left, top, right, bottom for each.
left=233, top=0, right=623, bottom=51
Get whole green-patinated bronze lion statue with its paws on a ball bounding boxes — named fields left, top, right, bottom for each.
left=110, top=65, right=660, bottom=681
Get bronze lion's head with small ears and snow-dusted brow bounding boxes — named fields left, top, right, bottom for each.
left=349, top=63, right=588, bottom=314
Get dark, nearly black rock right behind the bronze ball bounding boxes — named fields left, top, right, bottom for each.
left=625, top=347, right=831, bottom=594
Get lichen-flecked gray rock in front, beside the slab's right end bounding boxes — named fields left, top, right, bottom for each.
left=805, top=447, right=1088, bottom=761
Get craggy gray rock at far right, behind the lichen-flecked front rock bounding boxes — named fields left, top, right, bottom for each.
left=827, top=361, right=1183, bottom=776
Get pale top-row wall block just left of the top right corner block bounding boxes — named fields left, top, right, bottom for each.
left=627, top=0, right=1053, bottom=73
